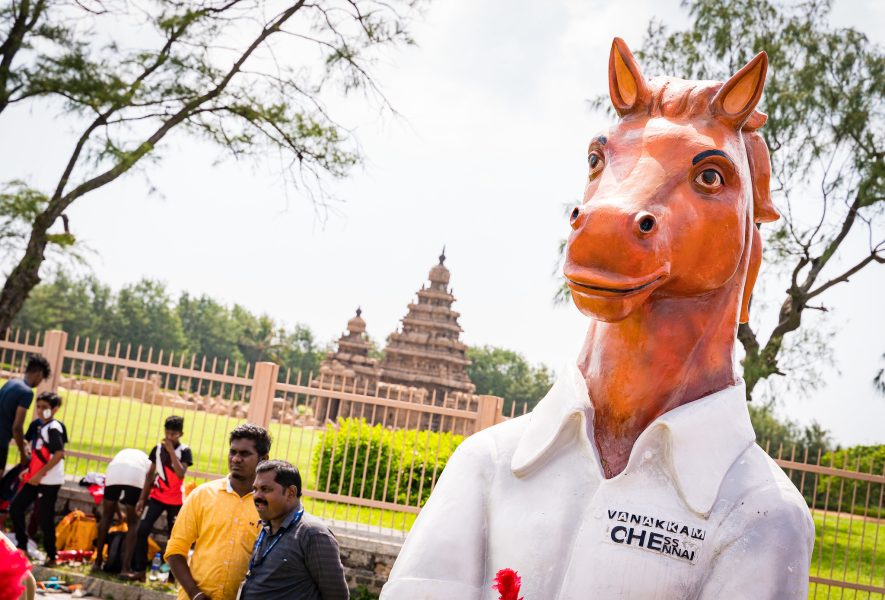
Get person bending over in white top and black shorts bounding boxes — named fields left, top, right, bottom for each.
left=92, top=448, right=151, bottom=572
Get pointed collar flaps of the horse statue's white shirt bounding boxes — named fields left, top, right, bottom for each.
left=510, top=364, right=756, bottom=515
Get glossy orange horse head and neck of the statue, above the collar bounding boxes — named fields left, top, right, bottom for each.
left=564, top=39, right=779, bottom=476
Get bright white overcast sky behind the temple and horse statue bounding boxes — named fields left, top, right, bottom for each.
left=0, top=0, right=885, bottom=444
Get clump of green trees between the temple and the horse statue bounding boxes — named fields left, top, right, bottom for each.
left=467, top=346, right=553, bottom=415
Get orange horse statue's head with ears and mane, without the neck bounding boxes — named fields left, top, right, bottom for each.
left=565, top=38, right=779, bottom=322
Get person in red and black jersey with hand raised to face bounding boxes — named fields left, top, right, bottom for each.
left=120, top=416, right=194, bottom=579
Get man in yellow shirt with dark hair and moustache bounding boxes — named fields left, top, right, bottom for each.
left=166, top=424, right=270, bottom=600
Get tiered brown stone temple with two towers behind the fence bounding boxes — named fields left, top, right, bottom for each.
left=313, top=249, right=476, bottom=422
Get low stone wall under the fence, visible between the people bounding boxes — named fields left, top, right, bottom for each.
left=56, top=479, right=402, bottom=594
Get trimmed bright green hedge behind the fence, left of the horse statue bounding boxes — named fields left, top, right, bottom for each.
left=308, top=419, right=464, bottom=506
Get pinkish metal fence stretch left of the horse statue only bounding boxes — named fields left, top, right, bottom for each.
left=0, top=331, right=503, bottom=533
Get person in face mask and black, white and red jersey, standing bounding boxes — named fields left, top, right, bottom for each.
left=9, top=392, right=68, bottom=566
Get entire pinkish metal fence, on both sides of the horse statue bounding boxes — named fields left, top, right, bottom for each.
left=0, top=332, right=885, bottom=600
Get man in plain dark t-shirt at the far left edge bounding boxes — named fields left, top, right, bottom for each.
left=0, top=354, right=50, bottom=476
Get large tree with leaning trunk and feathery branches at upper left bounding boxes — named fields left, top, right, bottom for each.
left=0, top=0, right=419, bottom=331
